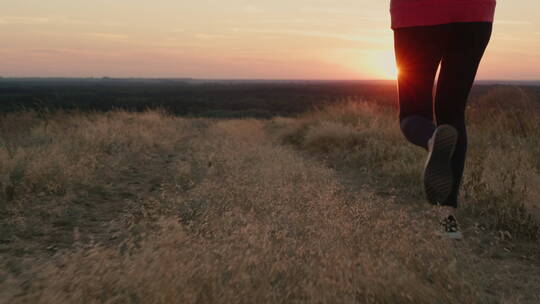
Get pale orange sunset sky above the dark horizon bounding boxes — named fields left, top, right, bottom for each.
left=0, top=0, right=540, bottom=80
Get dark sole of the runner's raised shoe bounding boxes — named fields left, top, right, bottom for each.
left=424, top=125, right=458, bottom=205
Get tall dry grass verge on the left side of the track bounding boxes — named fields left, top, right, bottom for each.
left=0, top=111, right=179, bottom=201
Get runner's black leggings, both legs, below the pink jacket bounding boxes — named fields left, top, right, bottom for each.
left=394, top=22, right=492, bottom=207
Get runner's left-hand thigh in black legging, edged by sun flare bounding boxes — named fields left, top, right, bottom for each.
left=394, top=26, right=444, bottom=120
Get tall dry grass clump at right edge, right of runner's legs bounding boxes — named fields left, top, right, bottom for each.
left=464, top=87, right=540, bottom=239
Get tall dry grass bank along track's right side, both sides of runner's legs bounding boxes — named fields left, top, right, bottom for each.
left=276, top=87, right=540, bottom=239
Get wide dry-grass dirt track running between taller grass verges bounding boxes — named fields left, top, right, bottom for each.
left=0, top=115, right=540, bottom=303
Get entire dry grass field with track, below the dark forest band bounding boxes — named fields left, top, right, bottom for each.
left=0, top=88, right=540, bottom=303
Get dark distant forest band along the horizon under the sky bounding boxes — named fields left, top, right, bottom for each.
left=0, top=78, right=540, bottom=118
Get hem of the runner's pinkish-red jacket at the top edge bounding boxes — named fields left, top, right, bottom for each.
left=390, top=0, right=496, bottom=29
